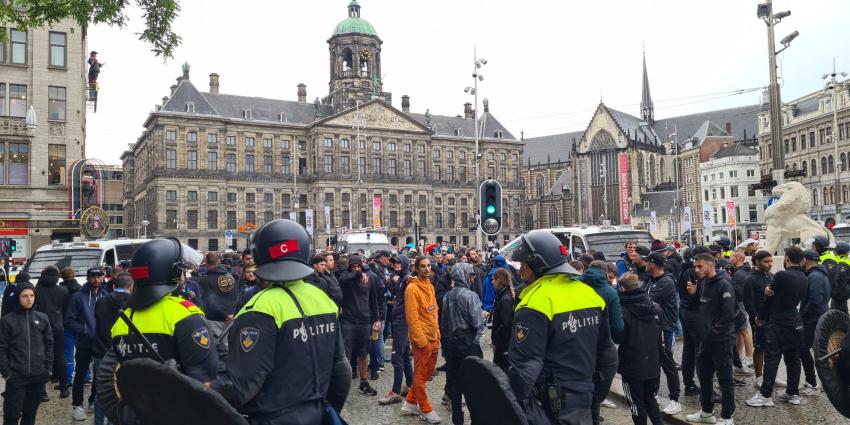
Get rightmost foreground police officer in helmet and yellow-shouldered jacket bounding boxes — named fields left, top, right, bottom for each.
left=508, top=230, right=617, bottom=424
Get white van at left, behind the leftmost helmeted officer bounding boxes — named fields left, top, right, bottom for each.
left=24, top=239, right=149, bottom=285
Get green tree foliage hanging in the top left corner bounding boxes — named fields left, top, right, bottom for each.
left=0, top=0, right=180, bottom=58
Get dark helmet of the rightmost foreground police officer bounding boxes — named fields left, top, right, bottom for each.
left=511, top=230, right=581, bottom=276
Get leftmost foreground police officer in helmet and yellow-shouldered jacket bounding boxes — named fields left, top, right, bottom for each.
left=98, top=239, right=218, bottom=424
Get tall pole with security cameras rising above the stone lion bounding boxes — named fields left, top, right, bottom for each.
left=757, top=0, right=799, bottom=180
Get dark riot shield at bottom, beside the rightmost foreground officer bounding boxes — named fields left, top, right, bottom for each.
left=460, top=356, right=528, bottom=425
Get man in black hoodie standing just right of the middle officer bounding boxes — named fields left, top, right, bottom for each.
left=339, top=255, right=381, bottom=395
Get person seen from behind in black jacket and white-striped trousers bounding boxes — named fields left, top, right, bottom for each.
left=615, top=272, right=662, bottom=425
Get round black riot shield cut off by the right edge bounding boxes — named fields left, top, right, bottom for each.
left=813, top=310, right=850, bottom=418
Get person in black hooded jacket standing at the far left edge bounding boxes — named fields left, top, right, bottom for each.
left=0, top=281, right=53, bottom=425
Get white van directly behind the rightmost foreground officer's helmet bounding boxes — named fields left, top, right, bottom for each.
left=499, top=226, right=655, bottom=261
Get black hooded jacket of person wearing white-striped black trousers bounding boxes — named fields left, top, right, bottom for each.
left=615, top=288, right=661, bottom=380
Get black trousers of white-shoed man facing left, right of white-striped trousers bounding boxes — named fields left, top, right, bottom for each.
left=697, top=340, right=735, bottom=419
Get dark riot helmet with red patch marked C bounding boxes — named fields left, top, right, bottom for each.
left=252, top=219, right=313, bottom=282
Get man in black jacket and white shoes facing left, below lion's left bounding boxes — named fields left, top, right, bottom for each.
left=687, top=254, right=736, bottom=425
